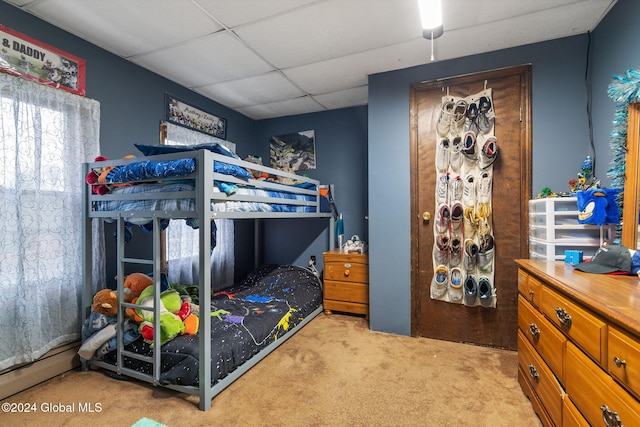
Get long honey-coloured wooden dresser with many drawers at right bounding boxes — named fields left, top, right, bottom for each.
left=516, top=260, right=640, bottom=427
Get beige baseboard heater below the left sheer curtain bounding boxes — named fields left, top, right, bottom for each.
left=0, top=341, right=80, bottom=400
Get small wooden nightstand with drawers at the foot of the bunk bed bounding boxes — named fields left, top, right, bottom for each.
left=323, top=250, right=369, bottom=319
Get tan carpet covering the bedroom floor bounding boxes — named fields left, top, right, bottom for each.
left=0, top=314, right=541, bottom=427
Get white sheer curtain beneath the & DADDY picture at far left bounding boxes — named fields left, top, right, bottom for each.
left=0, top=73, right=100, bottom=370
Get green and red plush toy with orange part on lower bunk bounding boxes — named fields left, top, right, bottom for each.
left=135, top=286, right=198, bottom=345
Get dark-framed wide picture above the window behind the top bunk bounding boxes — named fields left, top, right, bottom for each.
left=164, top=93, right=227, bottom=139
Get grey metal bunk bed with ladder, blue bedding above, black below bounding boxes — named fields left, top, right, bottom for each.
left=82, top=147, right=335, bottom=410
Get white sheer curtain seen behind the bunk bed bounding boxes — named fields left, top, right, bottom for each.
left=162, top=123, right=236, bottom=289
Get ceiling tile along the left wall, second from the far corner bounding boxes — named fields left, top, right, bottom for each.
left=195, top=72, right=305, bottom=108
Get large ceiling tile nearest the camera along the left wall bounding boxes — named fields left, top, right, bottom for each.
left=21, top=0, right=221, bottom=57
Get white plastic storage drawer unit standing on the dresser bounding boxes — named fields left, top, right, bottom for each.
left=529, top=197, right=614, bottom=260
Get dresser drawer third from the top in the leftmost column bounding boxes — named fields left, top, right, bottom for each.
left=518, top=331, right=564, bottom=426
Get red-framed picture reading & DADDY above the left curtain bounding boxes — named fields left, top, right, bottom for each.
left=0, top=25, right=87, bottom=96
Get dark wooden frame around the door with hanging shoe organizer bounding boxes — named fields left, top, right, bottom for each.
left=409, top=64, right=532, bottom=337
